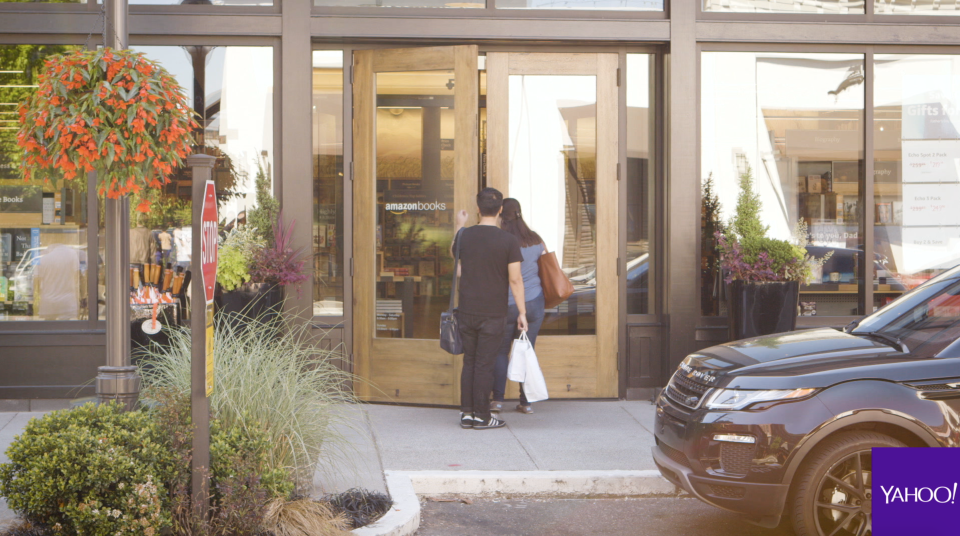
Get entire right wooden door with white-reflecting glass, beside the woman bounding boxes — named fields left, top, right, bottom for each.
left=482, top=52, right=620, bottom=398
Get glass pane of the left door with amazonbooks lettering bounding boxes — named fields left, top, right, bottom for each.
left=375, top=70, right=456, bottom=339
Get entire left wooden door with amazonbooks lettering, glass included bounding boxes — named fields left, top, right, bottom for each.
left=353, top=45, right=479, bottom=405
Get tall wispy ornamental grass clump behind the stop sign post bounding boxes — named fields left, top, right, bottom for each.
left=141, top=315, right=354, bottom=486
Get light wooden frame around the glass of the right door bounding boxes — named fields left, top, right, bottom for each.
left=486, top=52, right=623, bottom=398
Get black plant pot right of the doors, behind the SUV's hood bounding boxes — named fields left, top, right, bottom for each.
left=727, top=281, right=800, bottom=340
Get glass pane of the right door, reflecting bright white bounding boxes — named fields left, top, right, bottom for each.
left=509, top=75, right=597, bottom=335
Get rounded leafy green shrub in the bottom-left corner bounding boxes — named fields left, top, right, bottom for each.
left=0, top=403, right=176, bottom=536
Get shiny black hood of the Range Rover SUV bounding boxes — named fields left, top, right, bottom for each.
left=680, top=328, right=915, bottom=389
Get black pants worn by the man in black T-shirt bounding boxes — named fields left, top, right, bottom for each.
left=457, top=313, right=506, bottom=421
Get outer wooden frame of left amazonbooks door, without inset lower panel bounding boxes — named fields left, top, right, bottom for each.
left=351, top=45, right=480, bottom=404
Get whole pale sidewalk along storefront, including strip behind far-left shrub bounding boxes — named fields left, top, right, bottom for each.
left=0, top=400, right=656, bottom=521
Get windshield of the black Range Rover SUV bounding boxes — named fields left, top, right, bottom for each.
left=880, top=279, right=960, bottom=357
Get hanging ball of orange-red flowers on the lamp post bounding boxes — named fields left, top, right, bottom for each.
left=17, top=48, right=198, bottom=212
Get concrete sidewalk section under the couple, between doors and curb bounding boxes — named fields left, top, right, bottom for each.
left=364, top=400, right=656, bottom=471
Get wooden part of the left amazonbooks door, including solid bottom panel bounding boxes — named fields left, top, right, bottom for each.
left=353, top=45, right=479, bottom=405
